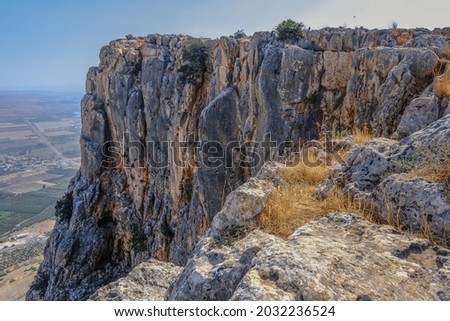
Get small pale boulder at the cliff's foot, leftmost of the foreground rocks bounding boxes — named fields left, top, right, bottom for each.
left=89, top=260, right=181, bottom=301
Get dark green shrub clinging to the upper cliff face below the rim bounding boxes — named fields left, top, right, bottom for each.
left=178, top=40, right=208, bottom=85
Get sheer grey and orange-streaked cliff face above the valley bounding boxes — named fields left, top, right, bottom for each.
left=28, top=29, right=450, bottom=300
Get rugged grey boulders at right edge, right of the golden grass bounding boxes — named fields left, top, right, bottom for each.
left=316, top=112, right=450, bottom=240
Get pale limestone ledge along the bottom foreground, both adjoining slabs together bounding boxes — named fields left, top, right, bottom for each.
left=120, top=213, right=450, bottom=301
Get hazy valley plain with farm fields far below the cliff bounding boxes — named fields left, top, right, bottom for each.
left=0, top=91, right=81, bottom=300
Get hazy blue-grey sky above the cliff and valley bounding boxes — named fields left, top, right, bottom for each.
left=0, top=0, right=450, bottom=91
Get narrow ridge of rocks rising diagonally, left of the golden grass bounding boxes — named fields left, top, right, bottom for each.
left=168, top=162, right=282, bottom=300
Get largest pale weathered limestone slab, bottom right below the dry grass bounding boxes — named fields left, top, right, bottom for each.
left=232, top=214, right=450, bottom=301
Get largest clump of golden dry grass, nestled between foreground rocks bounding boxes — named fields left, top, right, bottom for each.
left=259, top=158, right=374, bottom=237
